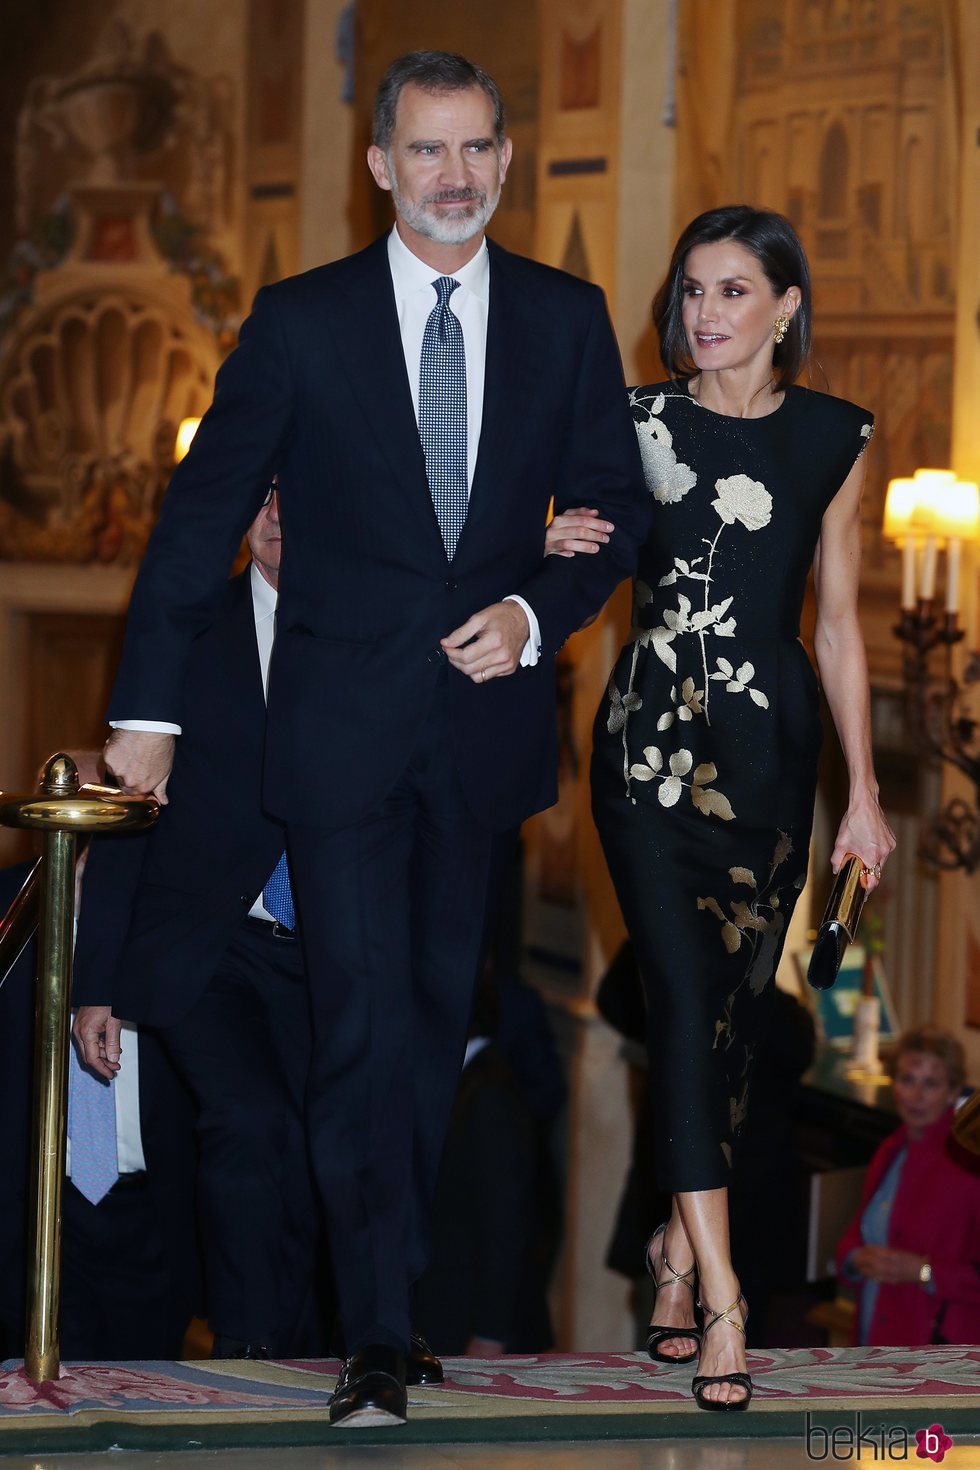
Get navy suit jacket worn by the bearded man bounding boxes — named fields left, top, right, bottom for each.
left=110, top=238, right=649, bottom=831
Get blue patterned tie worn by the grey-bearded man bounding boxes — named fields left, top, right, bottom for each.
left=419, top=276, right=469, bottom=560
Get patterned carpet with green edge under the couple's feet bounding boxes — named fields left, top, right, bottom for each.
left=0, top=1347, right=980, bottom=1457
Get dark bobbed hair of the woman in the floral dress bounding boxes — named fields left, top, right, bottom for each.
left=654, top=204, right=813, bottom=388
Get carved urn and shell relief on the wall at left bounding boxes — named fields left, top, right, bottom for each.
left=0, top=24, right=238, bottom=564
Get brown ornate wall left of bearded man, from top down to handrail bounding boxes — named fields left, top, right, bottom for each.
left=0, top=0, right=245, bottom=805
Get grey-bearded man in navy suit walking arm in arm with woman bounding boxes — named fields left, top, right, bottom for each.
left=88, top=53, right=648, bottom=1426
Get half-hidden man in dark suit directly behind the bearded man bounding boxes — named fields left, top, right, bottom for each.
left=75, top=490, right=316, bottom=1358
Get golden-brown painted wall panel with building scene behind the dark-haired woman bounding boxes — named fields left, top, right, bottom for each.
left=676, top=0, right=956, bottom=582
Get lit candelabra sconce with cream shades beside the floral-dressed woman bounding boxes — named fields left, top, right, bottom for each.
left=883, top=469, right=980, bottom=873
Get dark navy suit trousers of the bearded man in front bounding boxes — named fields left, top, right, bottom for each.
left=288, top=672, right=492, bottom=1352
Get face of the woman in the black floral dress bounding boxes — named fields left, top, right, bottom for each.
left=682, top=240, right=799, bottom=375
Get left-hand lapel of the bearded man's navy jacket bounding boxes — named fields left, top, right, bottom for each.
left=321, top=235, right=445, bottom=556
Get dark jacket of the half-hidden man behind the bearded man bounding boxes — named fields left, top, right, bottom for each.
left=73, top=570, right=285, bottom=1026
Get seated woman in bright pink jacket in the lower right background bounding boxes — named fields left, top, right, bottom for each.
left=837, top=1026, right=980, bottom=1347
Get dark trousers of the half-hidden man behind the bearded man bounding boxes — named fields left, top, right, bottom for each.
left=159, top=923, right=316, bottom=1352
